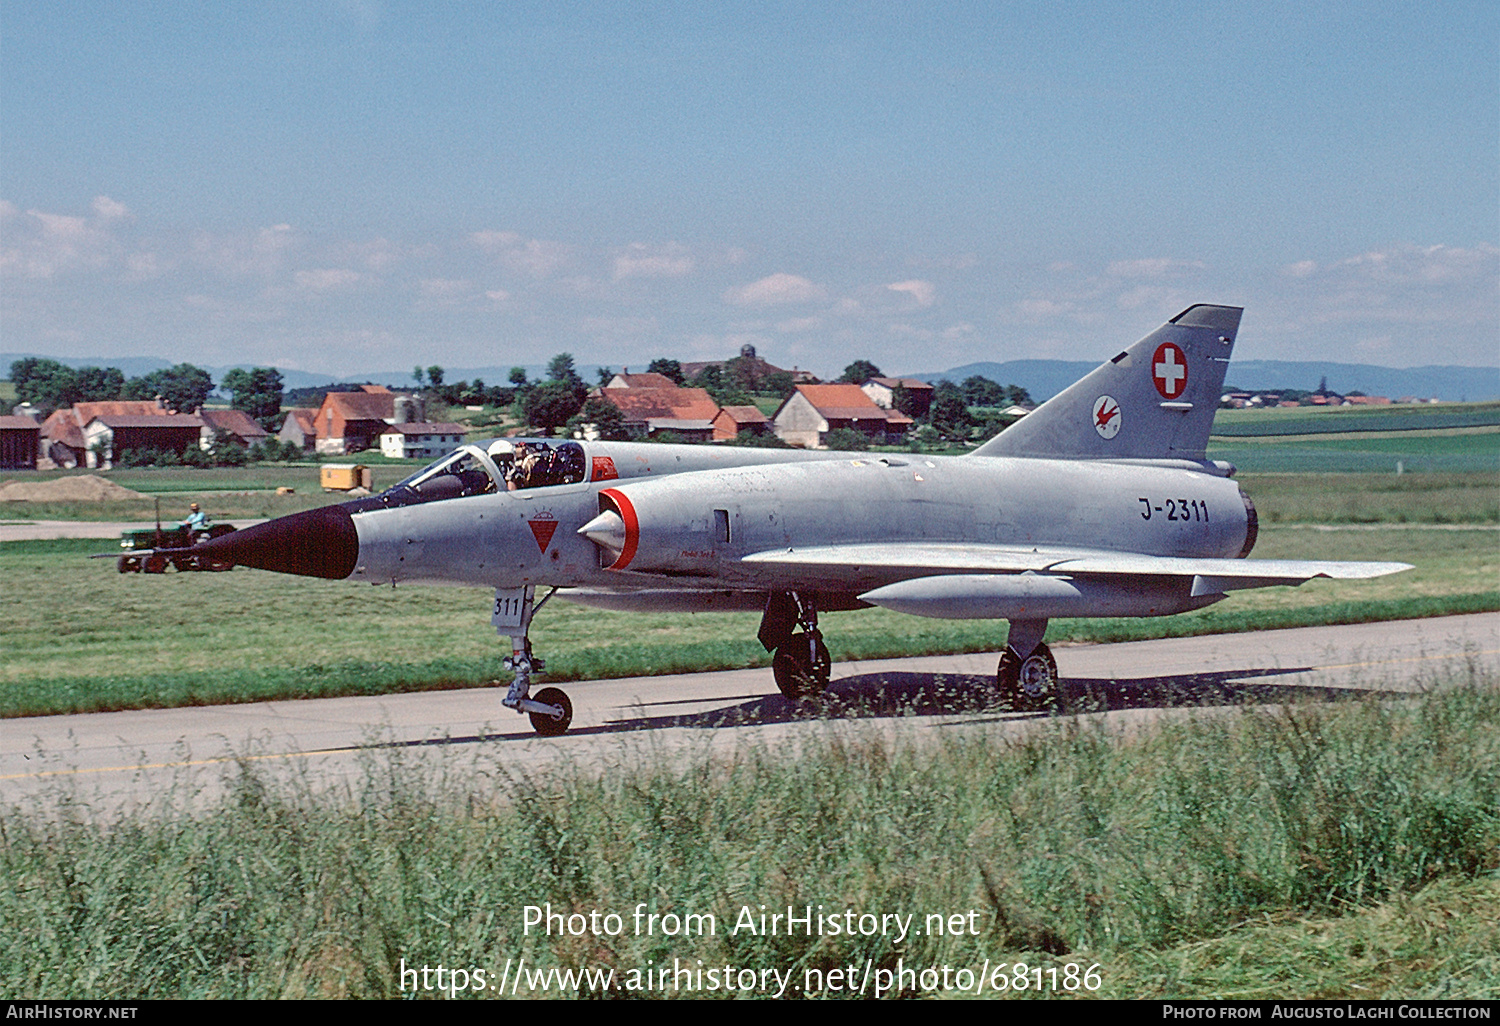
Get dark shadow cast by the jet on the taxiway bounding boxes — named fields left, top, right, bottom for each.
left=378, top=666, right=1368, bottom=747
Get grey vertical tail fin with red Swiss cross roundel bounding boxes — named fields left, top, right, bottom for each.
left=974, top=303, right=1244, bottom=459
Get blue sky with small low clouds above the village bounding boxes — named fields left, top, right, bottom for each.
left=0, top=0, right=1500, bottom=374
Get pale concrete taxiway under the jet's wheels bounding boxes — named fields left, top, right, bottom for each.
left=0, top=614, right=1500, bottom=818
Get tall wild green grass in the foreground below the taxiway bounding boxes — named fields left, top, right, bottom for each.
left=0, top=680, right=1500, bottom=998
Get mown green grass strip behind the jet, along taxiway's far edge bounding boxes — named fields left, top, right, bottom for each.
left=0, top=525, right=1500, bottom=716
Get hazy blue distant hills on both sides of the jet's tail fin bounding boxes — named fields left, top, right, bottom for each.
left=905, top=360, right=1500, bottom=402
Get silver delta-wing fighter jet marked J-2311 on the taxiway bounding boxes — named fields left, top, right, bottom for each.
left=188, top=305, right=1410, bottom=735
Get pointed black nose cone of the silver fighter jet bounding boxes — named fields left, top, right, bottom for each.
left=192, top=506, right=360, bottom=581
